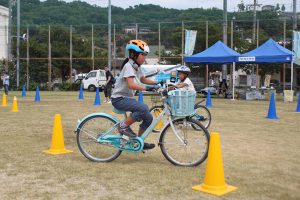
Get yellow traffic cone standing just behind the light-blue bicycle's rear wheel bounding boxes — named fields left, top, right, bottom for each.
left=43, top=114, right=73, bottom=155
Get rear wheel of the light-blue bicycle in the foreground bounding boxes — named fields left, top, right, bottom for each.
left=77, top=115, right=122, bottom=162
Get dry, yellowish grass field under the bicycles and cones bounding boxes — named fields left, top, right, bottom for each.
left=0, top=92, right=300, bottom=200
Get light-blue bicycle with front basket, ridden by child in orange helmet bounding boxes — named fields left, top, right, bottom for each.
left=76, top=90, right=210, bottom=166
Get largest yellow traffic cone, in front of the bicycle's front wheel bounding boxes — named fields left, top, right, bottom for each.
left=192, top=132, right=237, bottom=196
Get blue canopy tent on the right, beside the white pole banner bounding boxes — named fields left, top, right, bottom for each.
left=236, top=38, right=293, bottom=90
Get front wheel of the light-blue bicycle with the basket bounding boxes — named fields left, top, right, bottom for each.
left=159, top=118, right=209, bottom=167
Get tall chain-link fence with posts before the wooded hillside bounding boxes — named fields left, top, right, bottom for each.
left=0, top=19, right=292, bottom=90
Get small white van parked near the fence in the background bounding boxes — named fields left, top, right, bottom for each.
left=82, top=69, right=106, bottom=92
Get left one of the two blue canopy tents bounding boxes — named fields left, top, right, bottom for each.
left=184, top=41, right=241, bottom=99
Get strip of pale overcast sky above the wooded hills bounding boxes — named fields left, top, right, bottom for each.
left=65, top=0, right=300, bottom=11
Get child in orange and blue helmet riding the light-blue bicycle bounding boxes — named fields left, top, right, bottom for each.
left=111, top=40, right=159, bottom=149
